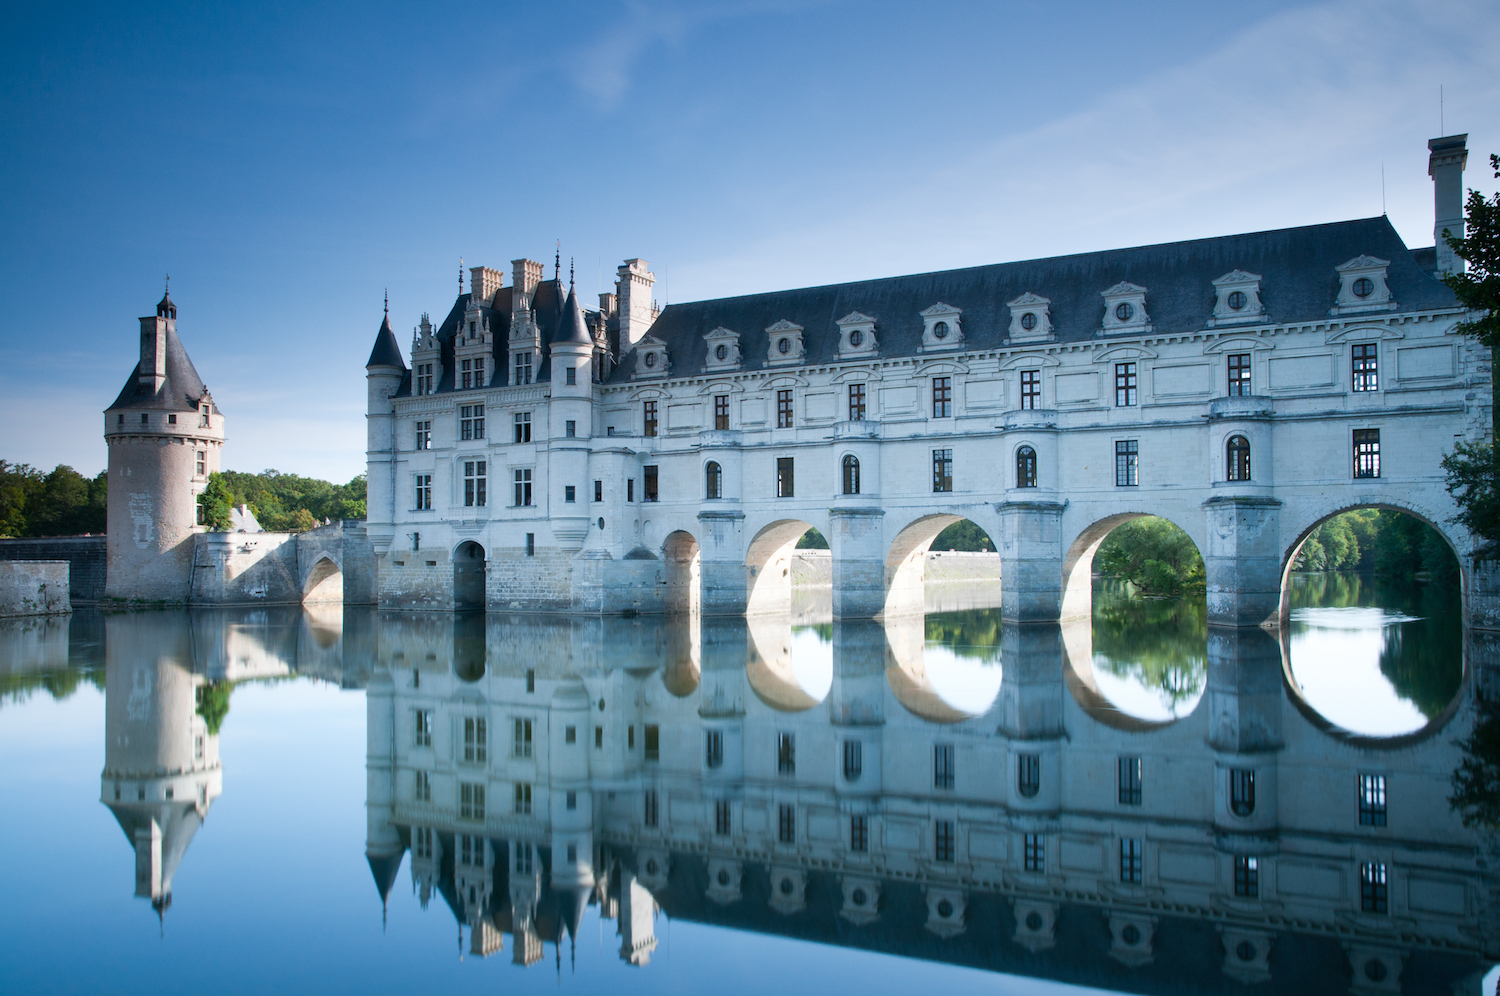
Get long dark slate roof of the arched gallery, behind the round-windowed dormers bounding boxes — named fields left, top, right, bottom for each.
left=609, top=216, right=1458, bottom=381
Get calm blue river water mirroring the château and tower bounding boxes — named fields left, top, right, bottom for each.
left=0, top=578, right=1500, bottom=993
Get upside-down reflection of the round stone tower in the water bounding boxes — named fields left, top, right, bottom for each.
left=101, top=615, right=224, bottom=912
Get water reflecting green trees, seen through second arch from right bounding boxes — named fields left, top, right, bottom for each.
left=1094, top=581, right=1208, bottom=714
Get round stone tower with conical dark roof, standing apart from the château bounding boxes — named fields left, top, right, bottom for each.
left=104, top=294, right=224, bottom=602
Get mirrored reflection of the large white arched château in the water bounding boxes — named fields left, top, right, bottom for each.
left=368, top=615, right=1500, bottom=993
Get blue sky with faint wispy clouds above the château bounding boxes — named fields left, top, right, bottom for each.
left=0, top=0, right=1500, bottom=480
